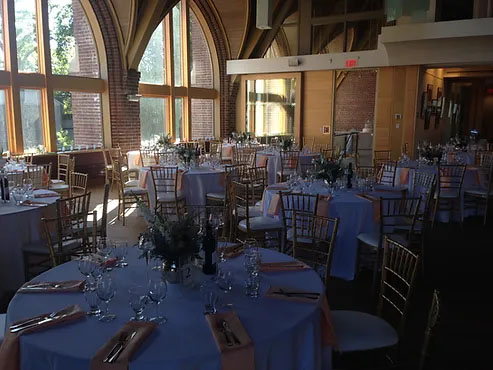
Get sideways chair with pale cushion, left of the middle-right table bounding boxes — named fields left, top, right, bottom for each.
left=230, top=181, right=283, bottom=251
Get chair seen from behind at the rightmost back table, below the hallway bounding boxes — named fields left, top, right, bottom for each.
left=432, top=165, right=467, bottom=227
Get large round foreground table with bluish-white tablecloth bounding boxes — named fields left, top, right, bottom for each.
left=7, top=248, right=331, bottom=370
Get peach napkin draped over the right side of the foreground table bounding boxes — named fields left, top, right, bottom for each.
left=265, top=286, right=337, bottom=347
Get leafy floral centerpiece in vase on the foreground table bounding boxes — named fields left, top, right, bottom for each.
left=137, top=200, right=200, bottom=283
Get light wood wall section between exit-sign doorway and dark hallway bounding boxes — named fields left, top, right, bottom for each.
left=373, top=66, right=419, bottom=159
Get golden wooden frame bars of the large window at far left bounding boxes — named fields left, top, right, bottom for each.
left=0, top=0, right=105, bottom=153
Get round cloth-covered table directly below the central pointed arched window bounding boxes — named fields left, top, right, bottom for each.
left=139, top=167, right=224, bottom=209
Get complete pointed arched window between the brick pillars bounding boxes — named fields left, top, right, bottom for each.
left=139, top=0, right=218, bottom=146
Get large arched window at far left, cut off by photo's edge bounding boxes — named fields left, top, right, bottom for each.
left=0, top=0, right=104, bottom=153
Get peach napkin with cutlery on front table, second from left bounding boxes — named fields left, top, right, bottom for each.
left=90, top=321, right=157, bottom=370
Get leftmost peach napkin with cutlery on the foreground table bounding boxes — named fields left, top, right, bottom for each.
left=0, top=305, right=86, bottom=370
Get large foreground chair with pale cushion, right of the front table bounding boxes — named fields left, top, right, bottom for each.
left=331, top=238, right=419, bottom=368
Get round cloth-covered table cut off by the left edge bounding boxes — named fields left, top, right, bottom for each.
left=0, top=190, right=58, bottom=293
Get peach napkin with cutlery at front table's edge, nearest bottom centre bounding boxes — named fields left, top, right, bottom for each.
left=206, top=311, right=255, bottom=370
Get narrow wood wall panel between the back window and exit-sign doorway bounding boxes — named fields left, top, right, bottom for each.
left=301, top=71, right=335, bottom=144
